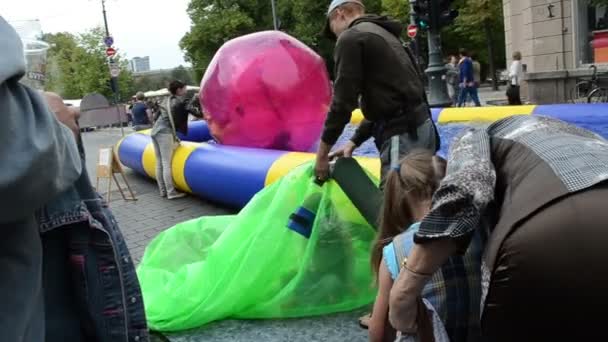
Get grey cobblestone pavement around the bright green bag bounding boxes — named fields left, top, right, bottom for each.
left=83, top=88, right=504, bottom=342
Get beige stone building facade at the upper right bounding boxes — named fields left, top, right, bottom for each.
left=503, top=0, right=608, bottom=104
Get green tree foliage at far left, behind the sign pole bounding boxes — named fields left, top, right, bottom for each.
left=44, top=27, right=133, bottom=100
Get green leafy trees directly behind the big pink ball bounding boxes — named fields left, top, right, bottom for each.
left=180, top=0, right=381, bottom=81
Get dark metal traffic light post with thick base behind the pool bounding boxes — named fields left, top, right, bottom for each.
left=425, top=0, right=452, bottom=107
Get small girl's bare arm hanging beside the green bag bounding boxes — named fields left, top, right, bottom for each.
left=369, top=260, right=394, bottom=342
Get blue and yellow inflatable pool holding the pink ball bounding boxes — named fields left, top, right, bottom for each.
left=117, top=104, right=608, bottom=208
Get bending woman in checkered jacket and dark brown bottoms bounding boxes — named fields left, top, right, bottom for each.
left=389, top=116, right=608, bottom=341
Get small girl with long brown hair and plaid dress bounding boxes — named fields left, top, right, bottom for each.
left=369, top=150, right=482, bottom=342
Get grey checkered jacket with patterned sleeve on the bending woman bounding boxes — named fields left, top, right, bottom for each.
left=415, top=116, right=608, bottom=243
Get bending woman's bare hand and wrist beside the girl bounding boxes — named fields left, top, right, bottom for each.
left=389, top=267, right=431, bottom=334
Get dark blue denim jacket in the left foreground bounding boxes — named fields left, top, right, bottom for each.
left=36, top=163, right=149, bottom=342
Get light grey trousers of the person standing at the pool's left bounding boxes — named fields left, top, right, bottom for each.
left=152, top=133, right=178, bottom=197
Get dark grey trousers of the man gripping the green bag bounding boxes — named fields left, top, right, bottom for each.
left=380, top=119, right=437, bottom=189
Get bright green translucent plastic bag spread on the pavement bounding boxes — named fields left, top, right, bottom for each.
left=137, top=164, right=376, bottom=331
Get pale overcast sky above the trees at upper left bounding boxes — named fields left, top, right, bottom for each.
left=0, top=0, right=190, bottom=69
